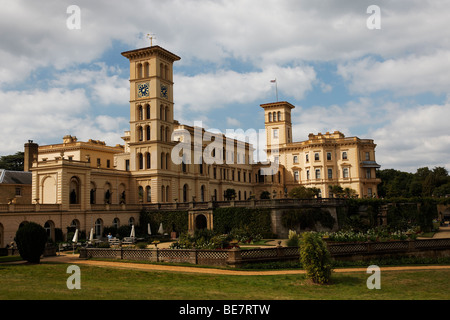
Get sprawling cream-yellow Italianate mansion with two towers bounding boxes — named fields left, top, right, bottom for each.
left=0, top=46, right=380, bottom=246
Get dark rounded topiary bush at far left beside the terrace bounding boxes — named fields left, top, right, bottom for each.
left=15, top=222, right=47, bottom=263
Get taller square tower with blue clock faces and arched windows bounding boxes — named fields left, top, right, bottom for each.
left=122, top=46, right=180, bottom=202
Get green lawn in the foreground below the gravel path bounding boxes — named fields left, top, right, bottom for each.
left=0, top=263, right=450, bottom=300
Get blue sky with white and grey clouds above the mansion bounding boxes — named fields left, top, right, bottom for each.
left=0, top=0, right=450, bottom=172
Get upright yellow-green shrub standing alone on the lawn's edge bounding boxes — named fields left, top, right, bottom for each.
left=300, top=232, right=332, bottom=284
